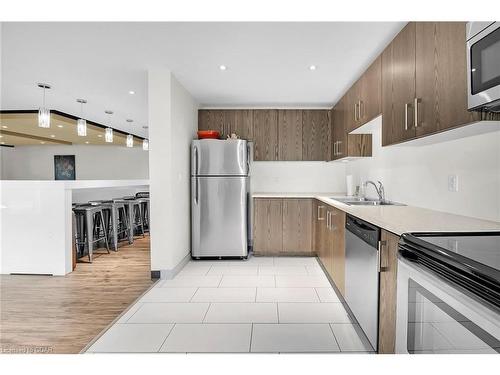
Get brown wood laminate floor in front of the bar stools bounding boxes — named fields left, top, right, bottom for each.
left=0, top=237, right=153, bottom=353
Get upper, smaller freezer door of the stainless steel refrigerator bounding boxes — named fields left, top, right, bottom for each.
left=191, top=139, right=249, bottom=176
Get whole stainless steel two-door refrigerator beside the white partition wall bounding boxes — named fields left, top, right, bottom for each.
left=191, top=139, right=250, bottom=258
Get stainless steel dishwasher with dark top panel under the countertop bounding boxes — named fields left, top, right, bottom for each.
left=345, top=215, right=380, bottom=350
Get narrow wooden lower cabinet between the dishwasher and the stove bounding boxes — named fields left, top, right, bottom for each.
left=378, top=230, right=399, bottom=354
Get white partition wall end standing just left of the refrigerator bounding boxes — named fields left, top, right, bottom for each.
left=148, top=68, right=198, bottom=277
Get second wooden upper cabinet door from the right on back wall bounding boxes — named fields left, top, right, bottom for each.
left=278, top=109, right=302, bottom=160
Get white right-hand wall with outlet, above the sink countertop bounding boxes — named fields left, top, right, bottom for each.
left=347, top=117, right=500, bottom=221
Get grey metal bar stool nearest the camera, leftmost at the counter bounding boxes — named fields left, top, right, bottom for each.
left=73, top=204, right=109, bottom=263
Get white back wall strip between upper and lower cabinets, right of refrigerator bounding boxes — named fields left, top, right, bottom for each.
left=250, top=161, right=346, bottom=193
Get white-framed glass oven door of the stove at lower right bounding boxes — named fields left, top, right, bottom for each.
left=396, top=255, right=500, bottom=354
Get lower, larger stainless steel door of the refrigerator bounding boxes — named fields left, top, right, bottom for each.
left=191, top=177, right=248, bottom=257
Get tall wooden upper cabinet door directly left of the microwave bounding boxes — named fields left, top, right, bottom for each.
left=413, top=22, right=479, bottom=136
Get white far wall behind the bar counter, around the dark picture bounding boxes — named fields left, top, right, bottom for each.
left=0, top=145, right=149, bottom=180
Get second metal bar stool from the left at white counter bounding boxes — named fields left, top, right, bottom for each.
left=89, top=199, right=133, bottom=251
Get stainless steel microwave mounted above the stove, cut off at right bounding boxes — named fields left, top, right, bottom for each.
left=467, top=22, right=500, bottom=112
